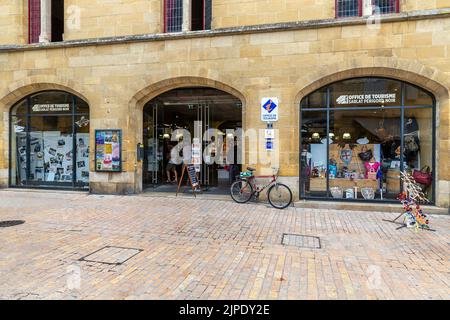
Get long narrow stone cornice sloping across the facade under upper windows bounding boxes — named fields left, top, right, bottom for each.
left=0, top=8, right=450, bottom=53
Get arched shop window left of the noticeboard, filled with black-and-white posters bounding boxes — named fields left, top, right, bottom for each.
left=9, top=91, right=90, bottom=188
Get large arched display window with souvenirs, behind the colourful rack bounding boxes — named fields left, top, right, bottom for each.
left=300, top=77, right=436, bottom=201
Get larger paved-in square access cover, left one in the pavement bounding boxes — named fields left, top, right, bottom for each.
left=79, top=246, right=144, bottom=265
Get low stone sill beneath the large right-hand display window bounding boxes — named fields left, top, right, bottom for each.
left=294, top=200, right=450, bottom=214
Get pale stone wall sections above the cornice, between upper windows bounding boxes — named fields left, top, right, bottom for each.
left=0, top=0, right=450, bottom=45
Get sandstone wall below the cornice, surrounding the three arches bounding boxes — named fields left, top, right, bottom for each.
left=0, top=16, right=450, bottom=207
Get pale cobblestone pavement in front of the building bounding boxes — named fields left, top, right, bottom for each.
left=0, top=190, right=450, bottom=299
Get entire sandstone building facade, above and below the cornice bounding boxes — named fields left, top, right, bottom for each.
left=0, top=0, right=450, bottom=207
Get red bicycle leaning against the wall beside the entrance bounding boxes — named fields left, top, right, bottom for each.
left=230, top=167, right=292, bottom=209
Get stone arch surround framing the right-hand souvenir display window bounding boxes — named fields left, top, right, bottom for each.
left=294, top=65, right=450, bottom=207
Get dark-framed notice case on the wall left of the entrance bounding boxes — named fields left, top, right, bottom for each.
left=95, top=129, right=122, bottom=172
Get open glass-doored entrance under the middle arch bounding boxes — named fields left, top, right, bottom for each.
left=143, top=87, right=242, bottom=193
